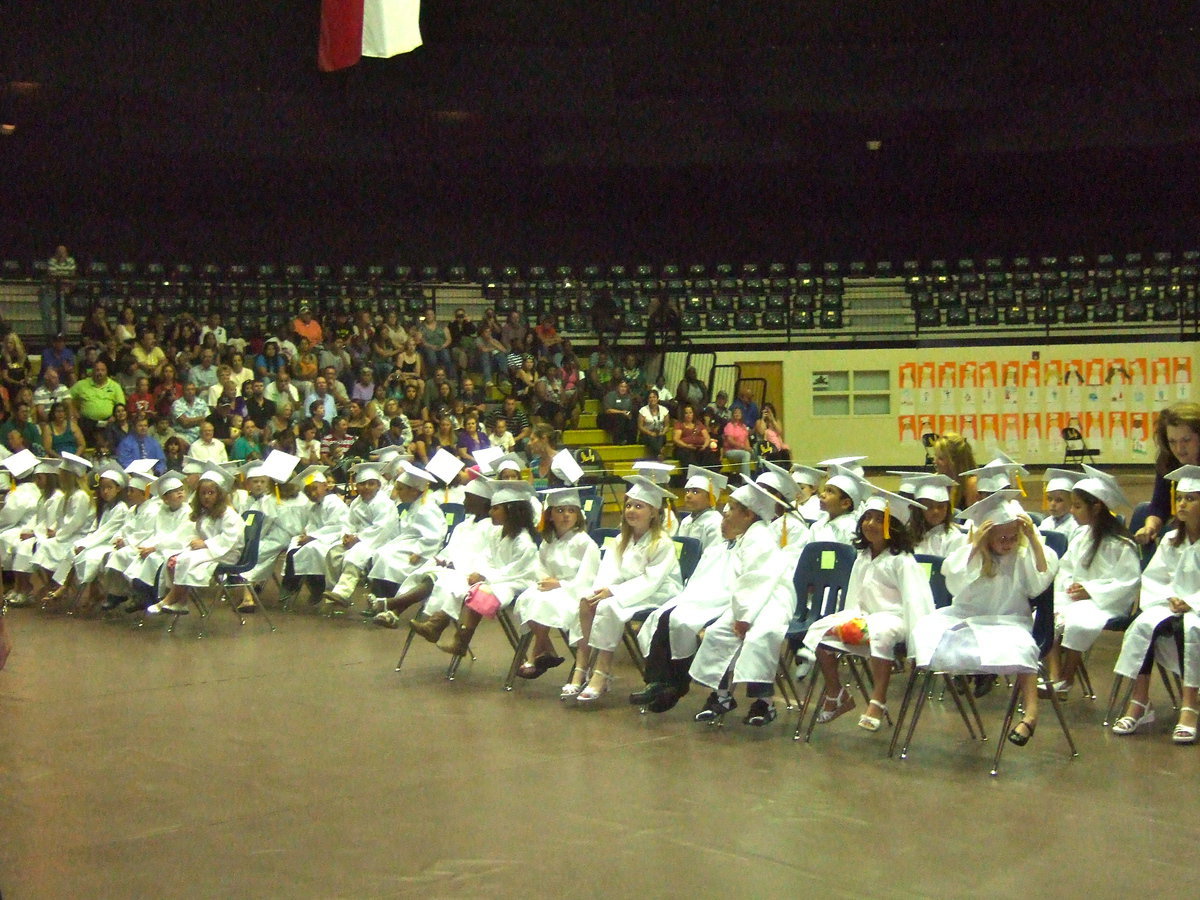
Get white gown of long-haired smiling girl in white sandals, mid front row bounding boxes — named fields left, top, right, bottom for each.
left=571, top=530, right=683, bottom=650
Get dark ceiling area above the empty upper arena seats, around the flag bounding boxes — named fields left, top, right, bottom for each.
left=0, top=0, right=1200, bottom=262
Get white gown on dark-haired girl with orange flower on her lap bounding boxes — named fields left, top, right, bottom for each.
left=804, top=550, right=934, bottom=660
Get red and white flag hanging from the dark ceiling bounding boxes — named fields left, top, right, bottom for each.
left=317, top=0, right=421, bottom=72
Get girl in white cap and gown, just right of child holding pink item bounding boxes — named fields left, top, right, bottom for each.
left=515, top=487, right=600, bottom=679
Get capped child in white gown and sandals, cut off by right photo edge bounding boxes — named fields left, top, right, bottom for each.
left=1112, top=466, right=1200, bottom=744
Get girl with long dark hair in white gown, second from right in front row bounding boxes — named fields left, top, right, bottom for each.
left=1049, top=466, right=1141, bottom=694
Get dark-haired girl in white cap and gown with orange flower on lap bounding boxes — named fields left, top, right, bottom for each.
left=804, top=494, right=934, bottom=731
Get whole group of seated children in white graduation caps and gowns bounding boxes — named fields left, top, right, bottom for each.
left=0, top=441, right=1200, bottom=744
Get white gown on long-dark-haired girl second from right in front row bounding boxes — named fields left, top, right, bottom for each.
left=1054, top=526, right=1141, bottom=653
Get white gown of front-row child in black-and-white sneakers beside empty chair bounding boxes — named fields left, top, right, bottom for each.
left=691, top=521, right=796, bottom=690
